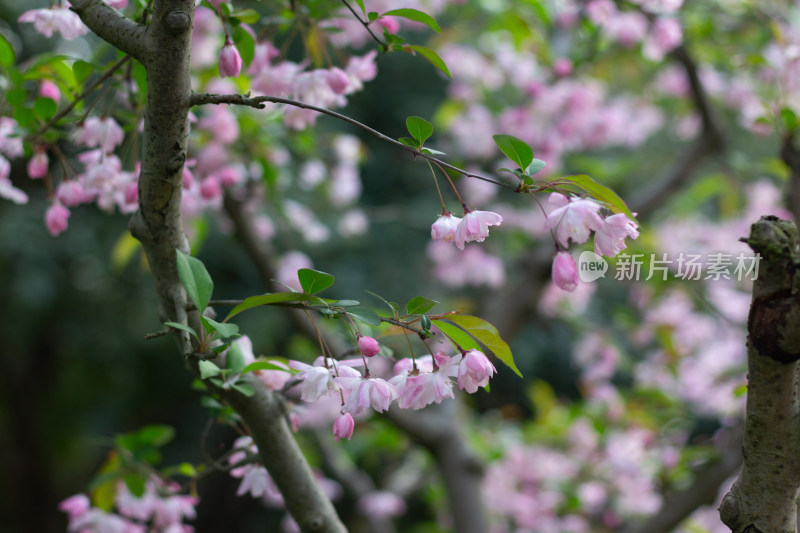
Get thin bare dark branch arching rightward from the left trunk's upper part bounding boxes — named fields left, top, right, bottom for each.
left=190, top=93, right=520, bottom=192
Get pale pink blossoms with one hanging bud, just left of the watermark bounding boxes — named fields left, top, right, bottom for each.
left=545, top=193, right=639, bottom=292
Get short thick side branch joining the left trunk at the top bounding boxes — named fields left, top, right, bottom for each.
left=70, top=0, right=147, bottom=63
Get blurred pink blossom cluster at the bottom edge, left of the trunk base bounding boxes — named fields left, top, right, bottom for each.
left=59, top=478, right=197, bottom=533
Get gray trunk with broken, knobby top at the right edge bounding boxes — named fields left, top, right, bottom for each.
left=720, top=217, right=800, bottom=533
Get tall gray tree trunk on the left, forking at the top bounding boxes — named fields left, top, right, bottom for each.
left=72, top=0, right=346, bottom=533
